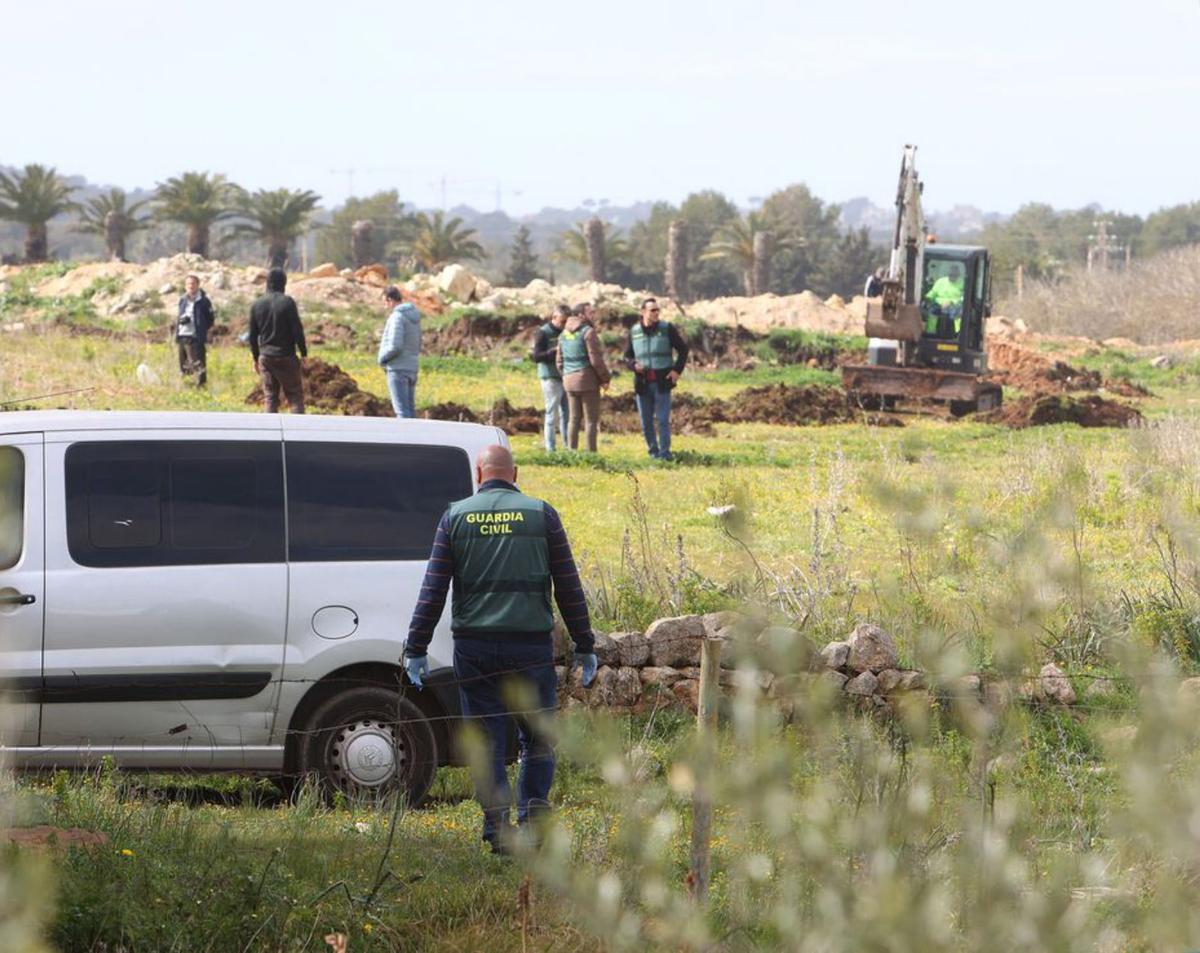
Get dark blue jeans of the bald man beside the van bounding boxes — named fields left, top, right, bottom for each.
left=454, top=636, right=558, bottom=843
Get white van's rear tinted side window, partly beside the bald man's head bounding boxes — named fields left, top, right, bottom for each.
left=284, top=440, right=473, bottom=562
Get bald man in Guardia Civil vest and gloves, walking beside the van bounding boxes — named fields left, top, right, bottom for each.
left=404, top=444, right=596, bottom=853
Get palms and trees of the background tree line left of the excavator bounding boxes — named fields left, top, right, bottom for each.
left=0, top=164, right=881, bottom=299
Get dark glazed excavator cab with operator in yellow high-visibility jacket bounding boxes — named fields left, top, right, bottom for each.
left=906, top=245, right=991, bottom=374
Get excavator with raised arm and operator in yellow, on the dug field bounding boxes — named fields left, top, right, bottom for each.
left=841, top=145, right=1003, bottom=415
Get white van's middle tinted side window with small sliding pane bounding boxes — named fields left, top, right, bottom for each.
left=66, top=440, right=284, bottom=568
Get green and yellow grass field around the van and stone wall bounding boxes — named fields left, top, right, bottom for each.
left=7, top=331, right=1200, bottom=951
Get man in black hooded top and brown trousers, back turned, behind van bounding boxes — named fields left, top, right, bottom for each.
left=250, top=268, right=308, bottom=414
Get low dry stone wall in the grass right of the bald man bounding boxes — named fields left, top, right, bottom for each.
left=556, top=612, right=1084, bottom=712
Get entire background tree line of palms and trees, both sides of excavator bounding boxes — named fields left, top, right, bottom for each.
left=9, top=164, right=1200, bottom=300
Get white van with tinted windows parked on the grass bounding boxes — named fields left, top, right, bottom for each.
left=0, top=410, right=508, bottom=802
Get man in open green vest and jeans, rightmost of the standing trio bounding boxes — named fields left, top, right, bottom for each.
left=625, top=298, right=688, bottom=460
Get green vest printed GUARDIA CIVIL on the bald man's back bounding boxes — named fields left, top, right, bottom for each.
left=450, top=487, right=554, bottom=635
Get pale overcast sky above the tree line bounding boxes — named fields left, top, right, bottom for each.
left=0, top=0, right=1200, bottom=214
